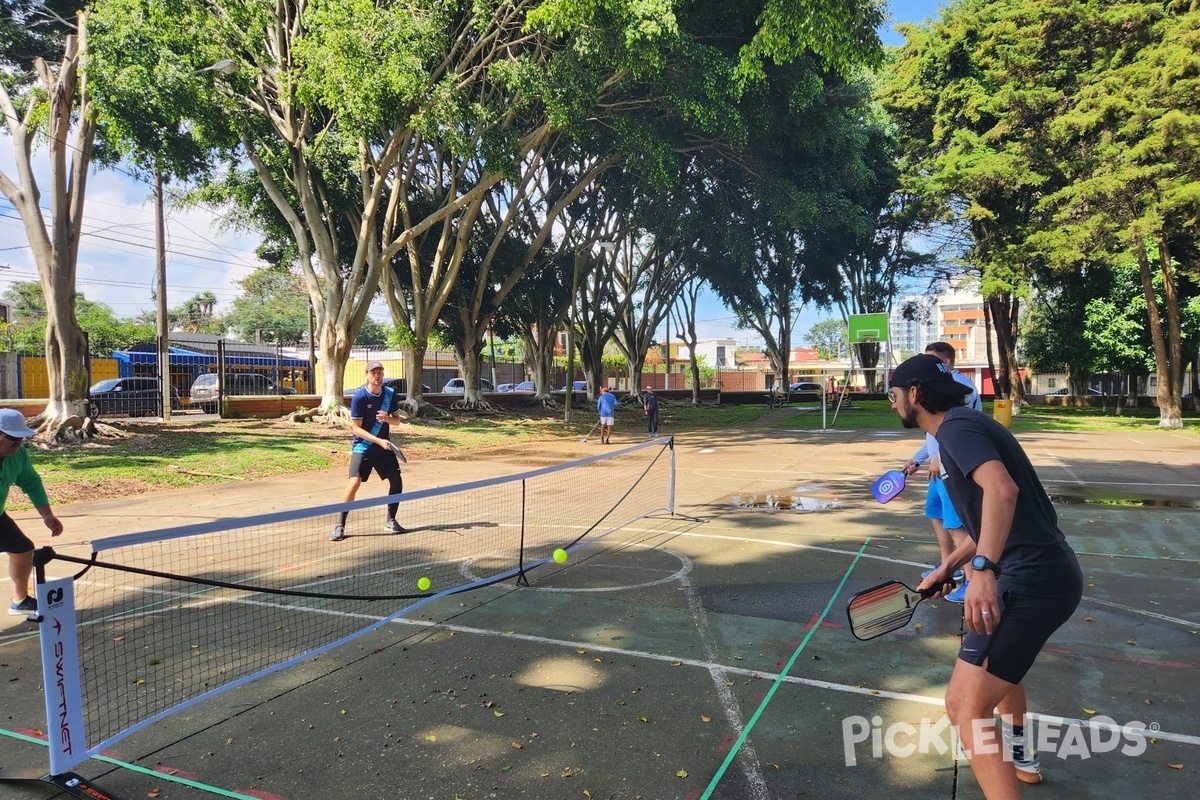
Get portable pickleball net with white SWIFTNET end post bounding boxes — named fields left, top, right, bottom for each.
left=0, top=439, right=674, bottom=798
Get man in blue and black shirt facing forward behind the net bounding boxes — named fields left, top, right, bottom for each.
left=329, top=361, right=406, bottom=542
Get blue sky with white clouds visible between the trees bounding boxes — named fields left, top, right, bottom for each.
left=0, top=0, right=942, bottom=345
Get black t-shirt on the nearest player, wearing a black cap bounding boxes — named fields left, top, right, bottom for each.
left=937, top=408, right=1074, bottom=582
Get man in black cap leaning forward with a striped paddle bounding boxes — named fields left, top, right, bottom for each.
left=888, top=355, right=1084, bottom=800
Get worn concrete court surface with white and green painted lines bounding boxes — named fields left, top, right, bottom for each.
left=0, top=419, right=1200, bottom=800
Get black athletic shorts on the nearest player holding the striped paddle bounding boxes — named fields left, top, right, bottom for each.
left=959, top=553, right=1084, bottom=684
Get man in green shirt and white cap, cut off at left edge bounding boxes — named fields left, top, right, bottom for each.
left=0, top=408, right=62, bottom=616
